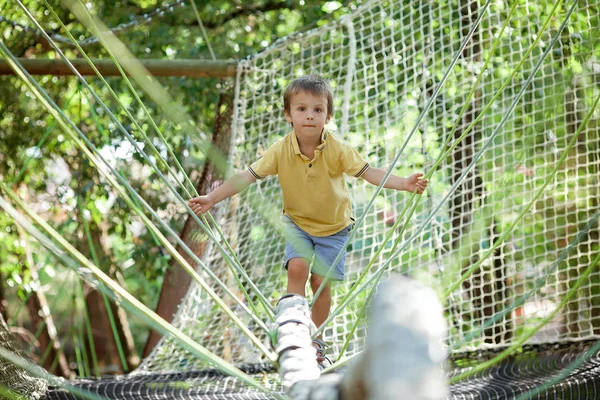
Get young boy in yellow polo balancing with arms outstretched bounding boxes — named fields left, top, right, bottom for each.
left=189, top=75, right=428, bottom=366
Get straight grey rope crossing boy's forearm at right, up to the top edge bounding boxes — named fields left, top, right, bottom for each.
left=310, top=0, right=491, bottom=306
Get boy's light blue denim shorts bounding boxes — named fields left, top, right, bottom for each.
left=283, top=215, right=352, bottom=281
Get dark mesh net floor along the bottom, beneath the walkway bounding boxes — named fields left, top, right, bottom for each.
left=47, top=346, right=600, bottom=400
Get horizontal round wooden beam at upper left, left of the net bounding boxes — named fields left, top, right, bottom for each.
left=0, top=58, right=237, bottom=78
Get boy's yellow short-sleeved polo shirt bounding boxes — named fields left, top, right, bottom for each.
left=248, top=130, right=369, bottom=237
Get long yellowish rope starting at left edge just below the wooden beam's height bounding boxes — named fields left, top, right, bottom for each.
left=0, top=41, right=274, bottom=361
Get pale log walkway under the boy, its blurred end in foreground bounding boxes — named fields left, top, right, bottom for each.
left=276, top=277, right=448, bottom=400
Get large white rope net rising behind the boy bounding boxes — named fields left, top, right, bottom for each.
left=138, top=0, right=600, bottom=373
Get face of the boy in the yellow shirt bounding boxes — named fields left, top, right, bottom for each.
left=285, top=92, right=329, bottom=139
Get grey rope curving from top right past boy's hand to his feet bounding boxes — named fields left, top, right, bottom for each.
left=315, top=0, right=577, bottom=335
